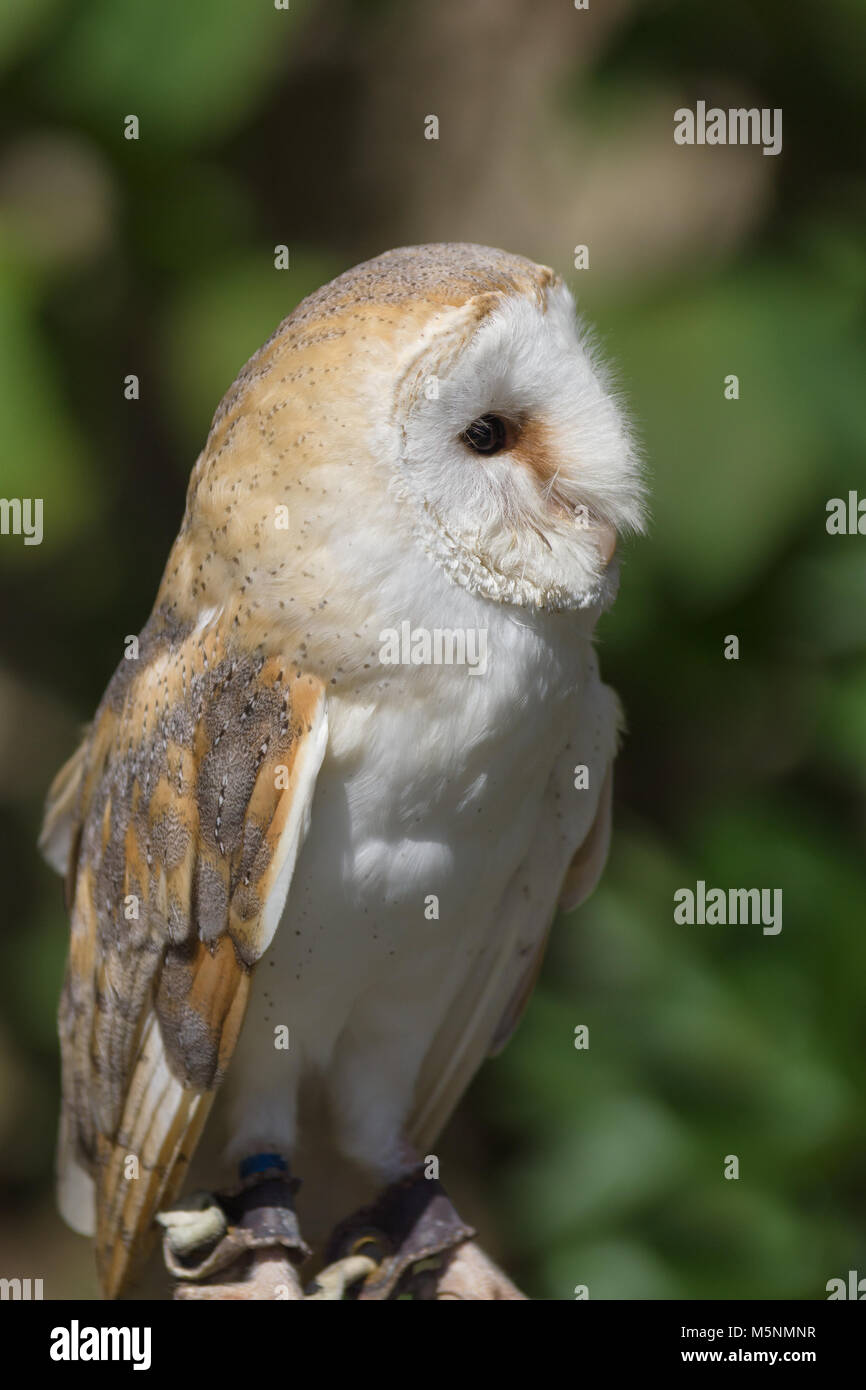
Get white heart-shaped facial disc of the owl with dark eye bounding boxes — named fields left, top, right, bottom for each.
left=374, top=245, right=644, bottom=610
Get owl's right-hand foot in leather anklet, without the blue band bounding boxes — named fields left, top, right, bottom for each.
left=316, top=1168, right=524, bottom=1301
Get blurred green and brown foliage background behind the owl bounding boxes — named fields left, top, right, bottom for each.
left=0, top=0, right=866, bottom=1298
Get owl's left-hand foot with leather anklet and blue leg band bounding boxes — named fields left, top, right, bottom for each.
left=157, top=1155, right=310, bottom=1300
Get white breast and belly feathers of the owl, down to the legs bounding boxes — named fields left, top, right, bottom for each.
left=196, top=547, right=616, bottom=1234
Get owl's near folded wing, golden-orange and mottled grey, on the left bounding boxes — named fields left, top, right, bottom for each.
left=42, top=620, right=327, bottom=1297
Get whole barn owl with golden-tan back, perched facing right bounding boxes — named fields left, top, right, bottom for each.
left=42, top=245, right=644, bottom=1297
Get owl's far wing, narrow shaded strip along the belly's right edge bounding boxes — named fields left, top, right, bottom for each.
left=407, top=711, right=619, bottom=1154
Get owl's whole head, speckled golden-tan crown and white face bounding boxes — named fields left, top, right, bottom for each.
left=180, top=243, right=644, bottom=625
